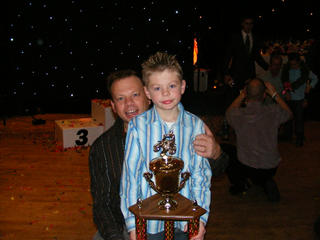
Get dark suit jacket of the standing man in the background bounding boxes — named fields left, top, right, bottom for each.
left=224, top=32, right=269, bottom=88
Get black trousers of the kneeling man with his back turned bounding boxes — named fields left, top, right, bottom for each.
left=226, top=153, right=278, bottom=190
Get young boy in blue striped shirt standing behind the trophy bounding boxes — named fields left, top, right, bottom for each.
left=120, top=52, right=211, bottom=240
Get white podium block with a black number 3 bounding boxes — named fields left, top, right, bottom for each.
left=55, top=118, right=104, bottom=148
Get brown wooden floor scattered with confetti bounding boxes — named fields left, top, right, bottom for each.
left=0, top=114, right=320, bottom=240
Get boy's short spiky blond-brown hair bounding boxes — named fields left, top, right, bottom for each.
left=141, top=52, right=183, bottom=85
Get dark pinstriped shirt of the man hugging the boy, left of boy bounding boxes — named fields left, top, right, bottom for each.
left=89, top=118, right=125, bottom=240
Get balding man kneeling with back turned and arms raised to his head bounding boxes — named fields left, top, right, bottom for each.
left=226, top=78, right=292, bottom=201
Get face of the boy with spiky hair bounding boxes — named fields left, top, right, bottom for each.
left=144, top=70, right=186, bottom=111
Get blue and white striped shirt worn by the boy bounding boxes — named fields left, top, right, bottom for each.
left=120, top=103, right=212, bottom=234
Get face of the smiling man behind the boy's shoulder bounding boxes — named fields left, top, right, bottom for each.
left=111, top=76, right=150, bottom=125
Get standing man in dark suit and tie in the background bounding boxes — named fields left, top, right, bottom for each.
left=222, top=16, right=268, bottom=140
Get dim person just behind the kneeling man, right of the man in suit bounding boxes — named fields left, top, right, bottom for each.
left=262, top=55, right=283, bottom=103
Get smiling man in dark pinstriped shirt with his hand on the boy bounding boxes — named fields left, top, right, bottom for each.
left=89, top=70, right=228, bottom=240
